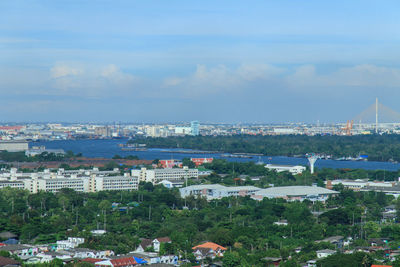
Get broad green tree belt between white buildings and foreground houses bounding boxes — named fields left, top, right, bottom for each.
left=0, top=184, right=400, bottom=266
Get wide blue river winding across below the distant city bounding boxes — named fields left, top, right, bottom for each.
left=31, top=140, right=400, bottom=171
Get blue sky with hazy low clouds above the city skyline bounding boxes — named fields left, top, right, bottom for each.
left=0, top=0, right=400, bottom=123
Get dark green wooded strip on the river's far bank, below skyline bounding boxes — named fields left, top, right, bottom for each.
left=137, top=135, right=400, bottom=161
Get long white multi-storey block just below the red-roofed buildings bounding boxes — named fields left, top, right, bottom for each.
left=131, top=166, right=199, bottom=184
